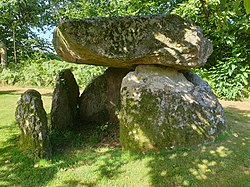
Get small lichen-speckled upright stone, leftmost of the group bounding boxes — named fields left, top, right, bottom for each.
left=15, top=90, right=51, bottom=159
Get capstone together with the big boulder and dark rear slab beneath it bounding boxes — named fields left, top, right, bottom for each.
left=53, top=15, right=226, bottom=152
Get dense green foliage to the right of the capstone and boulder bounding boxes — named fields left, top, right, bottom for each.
left=173, top=0, right=250, bottom=100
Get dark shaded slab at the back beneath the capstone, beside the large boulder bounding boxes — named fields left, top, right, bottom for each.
left=79, top=68, right=129, bottom=126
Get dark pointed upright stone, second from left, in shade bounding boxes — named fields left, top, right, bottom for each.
left=51, top=69, right=80, bottom=131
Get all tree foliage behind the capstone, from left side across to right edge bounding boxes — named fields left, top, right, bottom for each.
left=0, top=0, right=250, bottom=99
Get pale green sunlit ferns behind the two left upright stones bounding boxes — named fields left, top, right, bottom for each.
left=0, top=56, right=105, bottom=88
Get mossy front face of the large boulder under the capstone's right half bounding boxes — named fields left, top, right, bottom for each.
left=120, top=65, right=224, bottom=151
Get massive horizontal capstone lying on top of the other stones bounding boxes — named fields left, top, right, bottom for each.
left=53, top=15, right=212, bottom=69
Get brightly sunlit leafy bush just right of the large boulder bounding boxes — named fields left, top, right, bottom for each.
left=196, top=55, right=250, bottom=100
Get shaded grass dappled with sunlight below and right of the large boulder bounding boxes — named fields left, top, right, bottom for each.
left=147, top=108, right=250, bottom=187
